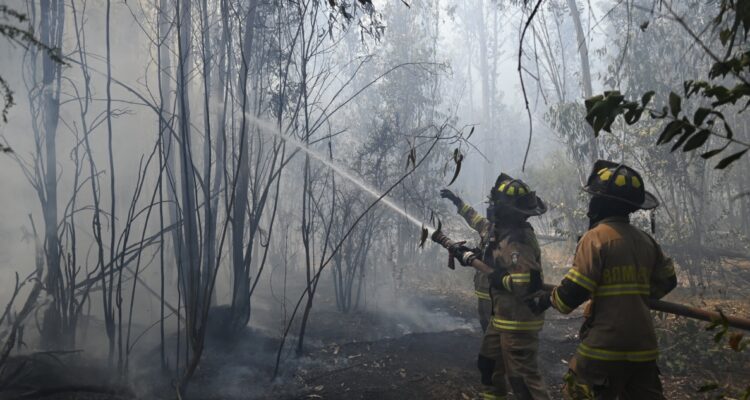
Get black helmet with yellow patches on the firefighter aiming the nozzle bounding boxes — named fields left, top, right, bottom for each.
left=490, top=173, right=547, bottom=216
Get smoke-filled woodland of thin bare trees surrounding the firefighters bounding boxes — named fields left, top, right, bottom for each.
left=0, top=0, right=750, bottom=399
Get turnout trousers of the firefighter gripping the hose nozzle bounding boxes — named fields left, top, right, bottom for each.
left=477, top=325, right=550, bottom=400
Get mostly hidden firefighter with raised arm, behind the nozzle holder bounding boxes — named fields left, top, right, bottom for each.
left=440, top=189, right=492, bottom=332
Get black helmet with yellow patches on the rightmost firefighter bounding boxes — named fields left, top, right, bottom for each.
left=583, top=160, right=659, bottom=210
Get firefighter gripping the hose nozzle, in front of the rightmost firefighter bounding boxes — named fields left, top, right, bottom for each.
left=444, top=174, right=549, bottom=400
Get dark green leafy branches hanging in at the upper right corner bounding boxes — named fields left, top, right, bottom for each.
left=585, top=0, right=750, bottom=169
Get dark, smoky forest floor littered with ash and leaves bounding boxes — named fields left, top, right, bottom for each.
left=0, top=268, right=750, bottom=400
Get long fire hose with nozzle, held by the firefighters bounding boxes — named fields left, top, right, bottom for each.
left=430, top=228, right=750, bottom=331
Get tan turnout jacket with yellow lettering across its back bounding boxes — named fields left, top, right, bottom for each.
left=552, top=217, right=674, bottom=362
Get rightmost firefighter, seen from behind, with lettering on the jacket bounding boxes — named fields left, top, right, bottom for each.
left=529, top=160, right=677, bottom=400
